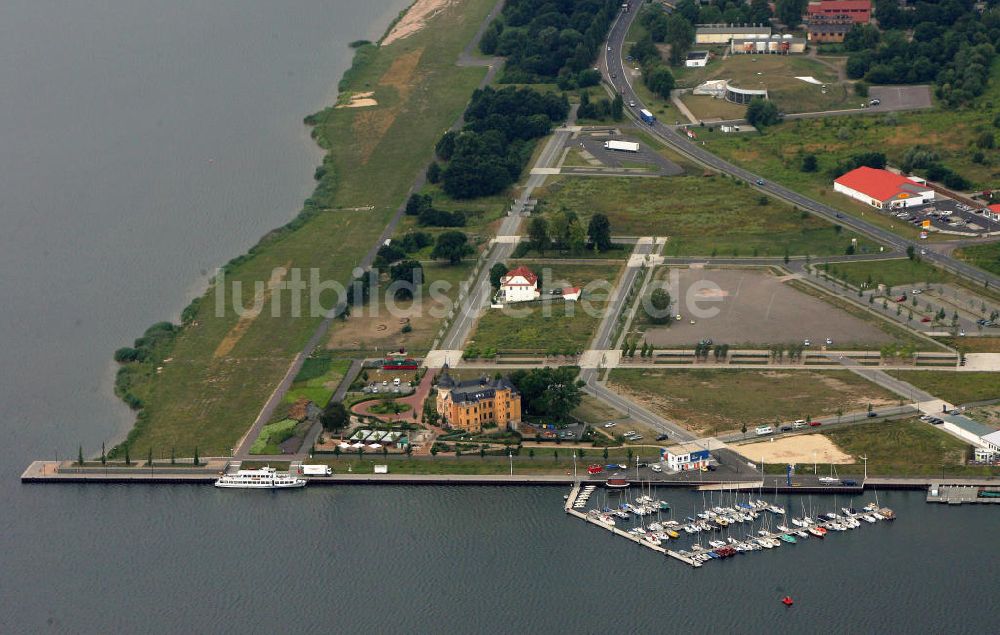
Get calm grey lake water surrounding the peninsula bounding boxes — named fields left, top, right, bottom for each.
left=0, top=0, right=1000, bottom=633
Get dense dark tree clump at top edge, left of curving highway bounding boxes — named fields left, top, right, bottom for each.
left=479, top=0, right=621, bottom=89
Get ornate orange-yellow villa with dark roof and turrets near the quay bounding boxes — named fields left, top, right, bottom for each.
left=435, top=366, right=521, bottom=432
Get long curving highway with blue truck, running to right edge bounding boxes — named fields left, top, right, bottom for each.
left=600, top=5, right=1000, bottom=288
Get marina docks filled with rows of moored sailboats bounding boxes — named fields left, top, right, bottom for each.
left=565, top=483, right=896, bottom=568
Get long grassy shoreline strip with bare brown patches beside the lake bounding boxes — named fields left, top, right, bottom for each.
left=111, top=0, right=493, bottom=455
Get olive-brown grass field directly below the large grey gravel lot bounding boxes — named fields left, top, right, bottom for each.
left=609, top=368, right=899, bottom=434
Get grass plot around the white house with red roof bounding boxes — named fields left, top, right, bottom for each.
left=467, top=260, right=621, bottom=354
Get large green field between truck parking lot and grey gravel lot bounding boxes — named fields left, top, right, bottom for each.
left=539, top=176, right=875, bottom=257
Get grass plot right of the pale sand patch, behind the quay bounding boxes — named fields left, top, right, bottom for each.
left=820, top=419, right=1000, bottom=476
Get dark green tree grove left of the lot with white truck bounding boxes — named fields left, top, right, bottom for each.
left=435, top=87, right=569, bottom=200
